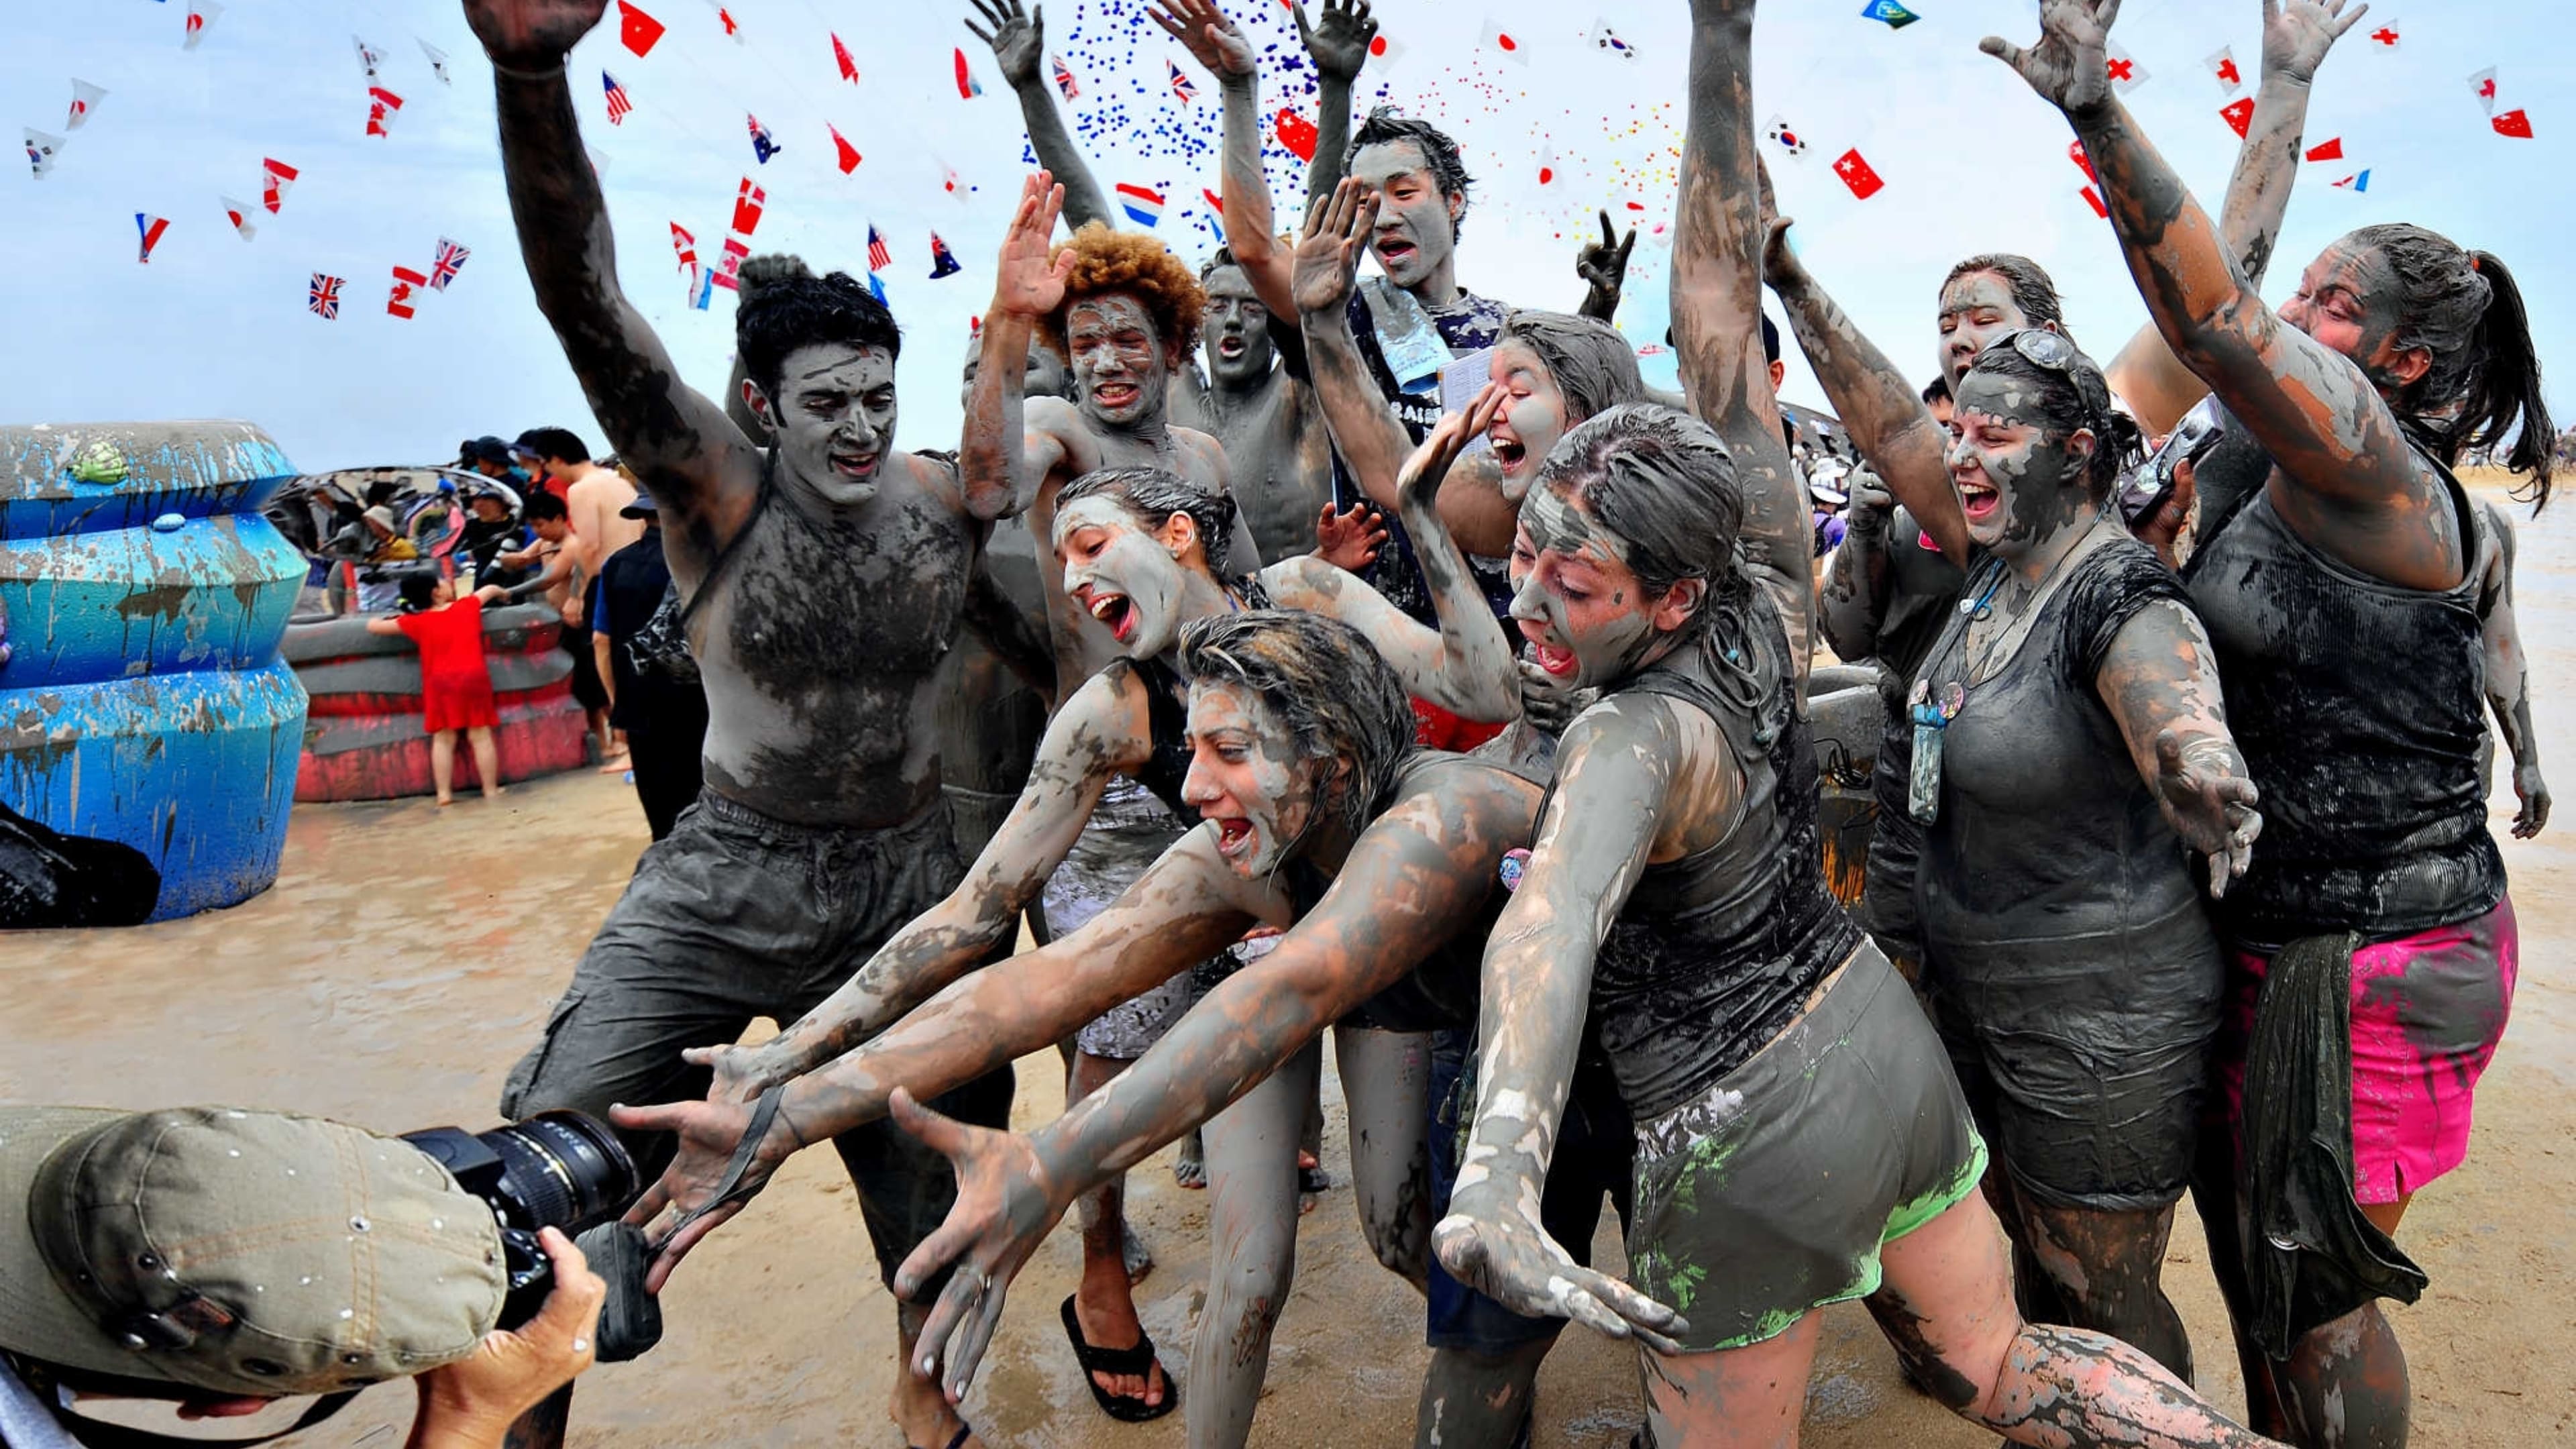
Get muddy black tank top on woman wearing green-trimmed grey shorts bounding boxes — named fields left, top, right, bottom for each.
left=1592, top=590, right=1860, bottom=1122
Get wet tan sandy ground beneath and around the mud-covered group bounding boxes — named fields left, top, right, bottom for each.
left=0, top=474, right=2576, bottom=1449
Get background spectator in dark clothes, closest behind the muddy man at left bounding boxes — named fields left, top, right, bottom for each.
left=590, top=490, right=706, bottom=841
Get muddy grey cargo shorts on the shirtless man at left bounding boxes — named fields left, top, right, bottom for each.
left=500, top=792, right=1012, bottom=1284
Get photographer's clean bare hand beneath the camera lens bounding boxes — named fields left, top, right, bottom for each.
left=410, top=1227, right=608, bottom=1449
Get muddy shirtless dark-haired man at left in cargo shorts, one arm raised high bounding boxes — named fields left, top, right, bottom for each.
left=466, top=0, right=1018, bottom=1444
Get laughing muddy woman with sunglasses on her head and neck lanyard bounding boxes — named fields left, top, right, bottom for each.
left=1907, top=327, right=2262, bottom=1379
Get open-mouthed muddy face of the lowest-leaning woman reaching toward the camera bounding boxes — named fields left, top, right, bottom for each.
left=1180, top=684, right=1324, bottom=879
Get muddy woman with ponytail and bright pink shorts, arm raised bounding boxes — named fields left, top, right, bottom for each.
left=1984, top=0, right=2553, bottom=1446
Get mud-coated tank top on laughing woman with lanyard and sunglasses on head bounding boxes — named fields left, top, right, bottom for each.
left=1909, top=539, right=2205, bottom=959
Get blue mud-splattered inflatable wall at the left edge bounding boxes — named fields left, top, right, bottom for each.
left=0, top=423, right=309, bottom=926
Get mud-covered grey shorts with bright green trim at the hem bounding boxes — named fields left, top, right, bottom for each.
left=1628, top=944, right=1986, bottom=1354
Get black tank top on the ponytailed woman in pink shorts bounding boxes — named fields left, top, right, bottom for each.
left=2184, top=453, right=2504, bottom=947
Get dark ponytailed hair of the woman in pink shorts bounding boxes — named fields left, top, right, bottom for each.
left=2344, top=222, right=2558, bottom=502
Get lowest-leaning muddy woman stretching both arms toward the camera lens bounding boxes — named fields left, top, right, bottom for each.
left=621, top=610, right=1538, bottom=1446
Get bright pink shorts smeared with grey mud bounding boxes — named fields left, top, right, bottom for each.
left=2218, top=900, right=2520, bottom=1204
